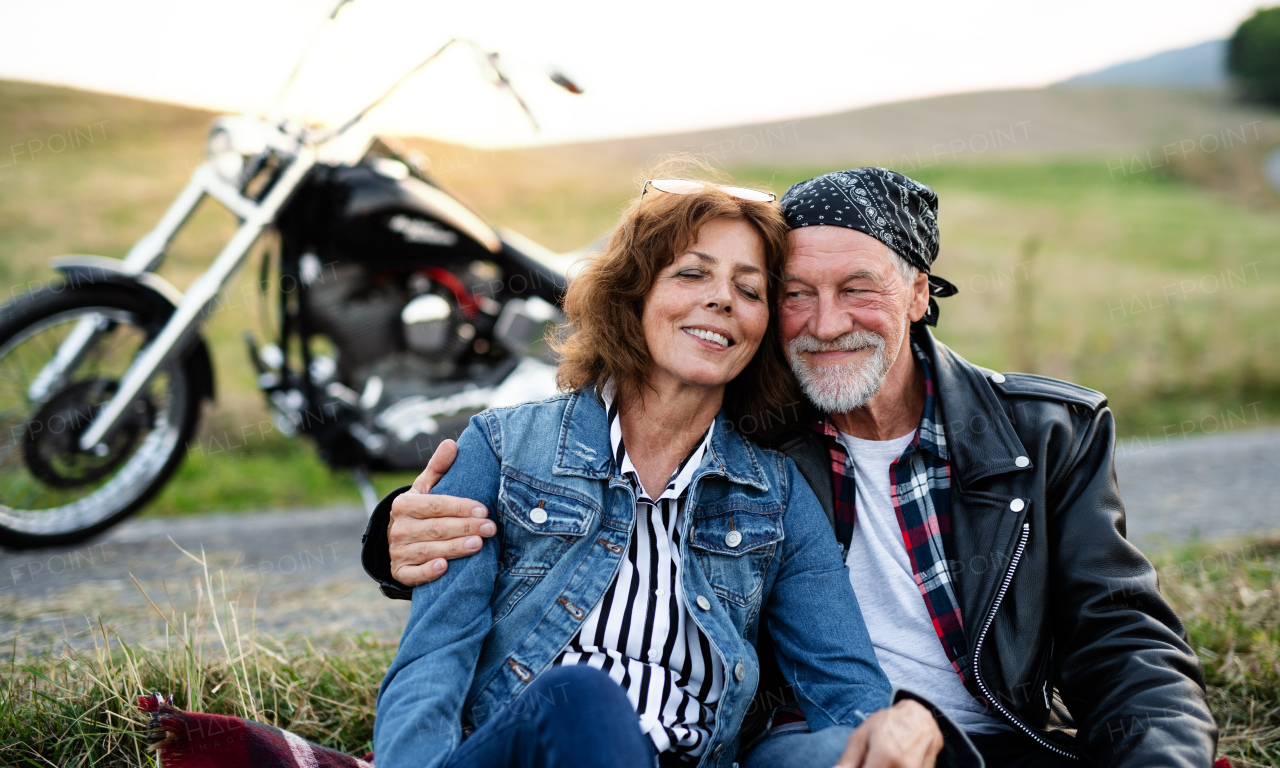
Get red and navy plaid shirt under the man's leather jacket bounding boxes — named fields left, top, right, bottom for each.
left=813, top=343, right=980, bottom=699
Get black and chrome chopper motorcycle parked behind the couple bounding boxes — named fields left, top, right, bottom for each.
left=0, top=3, right=581, bottom=548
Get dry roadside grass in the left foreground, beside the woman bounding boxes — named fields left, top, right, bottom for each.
left=0, top=542, right=396, bottom=767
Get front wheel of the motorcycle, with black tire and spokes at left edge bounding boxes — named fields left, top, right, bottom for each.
left=0, top=284, right=201, bottom=549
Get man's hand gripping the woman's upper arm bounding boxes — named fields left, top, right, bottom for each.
left=387, top=440, right=498, bottom=586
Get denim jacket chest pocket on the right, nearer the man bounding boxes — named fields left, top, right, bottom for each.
left=689, top=507, right=782, bottom=607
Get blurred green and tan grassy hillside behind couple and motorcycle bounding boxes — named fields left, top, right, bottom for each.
left=0, top=82, right=1280, bottom=511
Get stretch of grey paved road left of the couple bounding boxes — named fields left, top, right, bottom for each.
left=0, top=507, right=408, bottom=655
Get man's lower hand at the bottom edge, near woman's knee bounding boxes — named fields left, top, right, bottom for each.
left=836, top=699, right=942, bottom=768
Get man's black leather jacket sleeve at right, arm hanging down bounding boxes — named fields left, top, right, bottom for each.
left=1047, top=407, right=1217, bottom=768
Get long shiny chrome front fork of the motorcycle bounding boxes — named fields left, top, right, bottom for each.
left=70, top=150, right=316, bottom=451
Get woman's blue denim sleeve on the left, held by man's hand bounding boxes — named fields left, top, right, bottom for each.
left=374, top=413, right=500, bottom=768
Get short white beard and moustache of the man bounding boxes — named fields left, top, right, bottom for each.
left=787, top=330, right=890, bottom=413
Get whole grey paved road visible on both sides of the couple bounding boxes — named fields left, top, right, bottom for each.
left=0, top=430, right=1280, bottom=654
